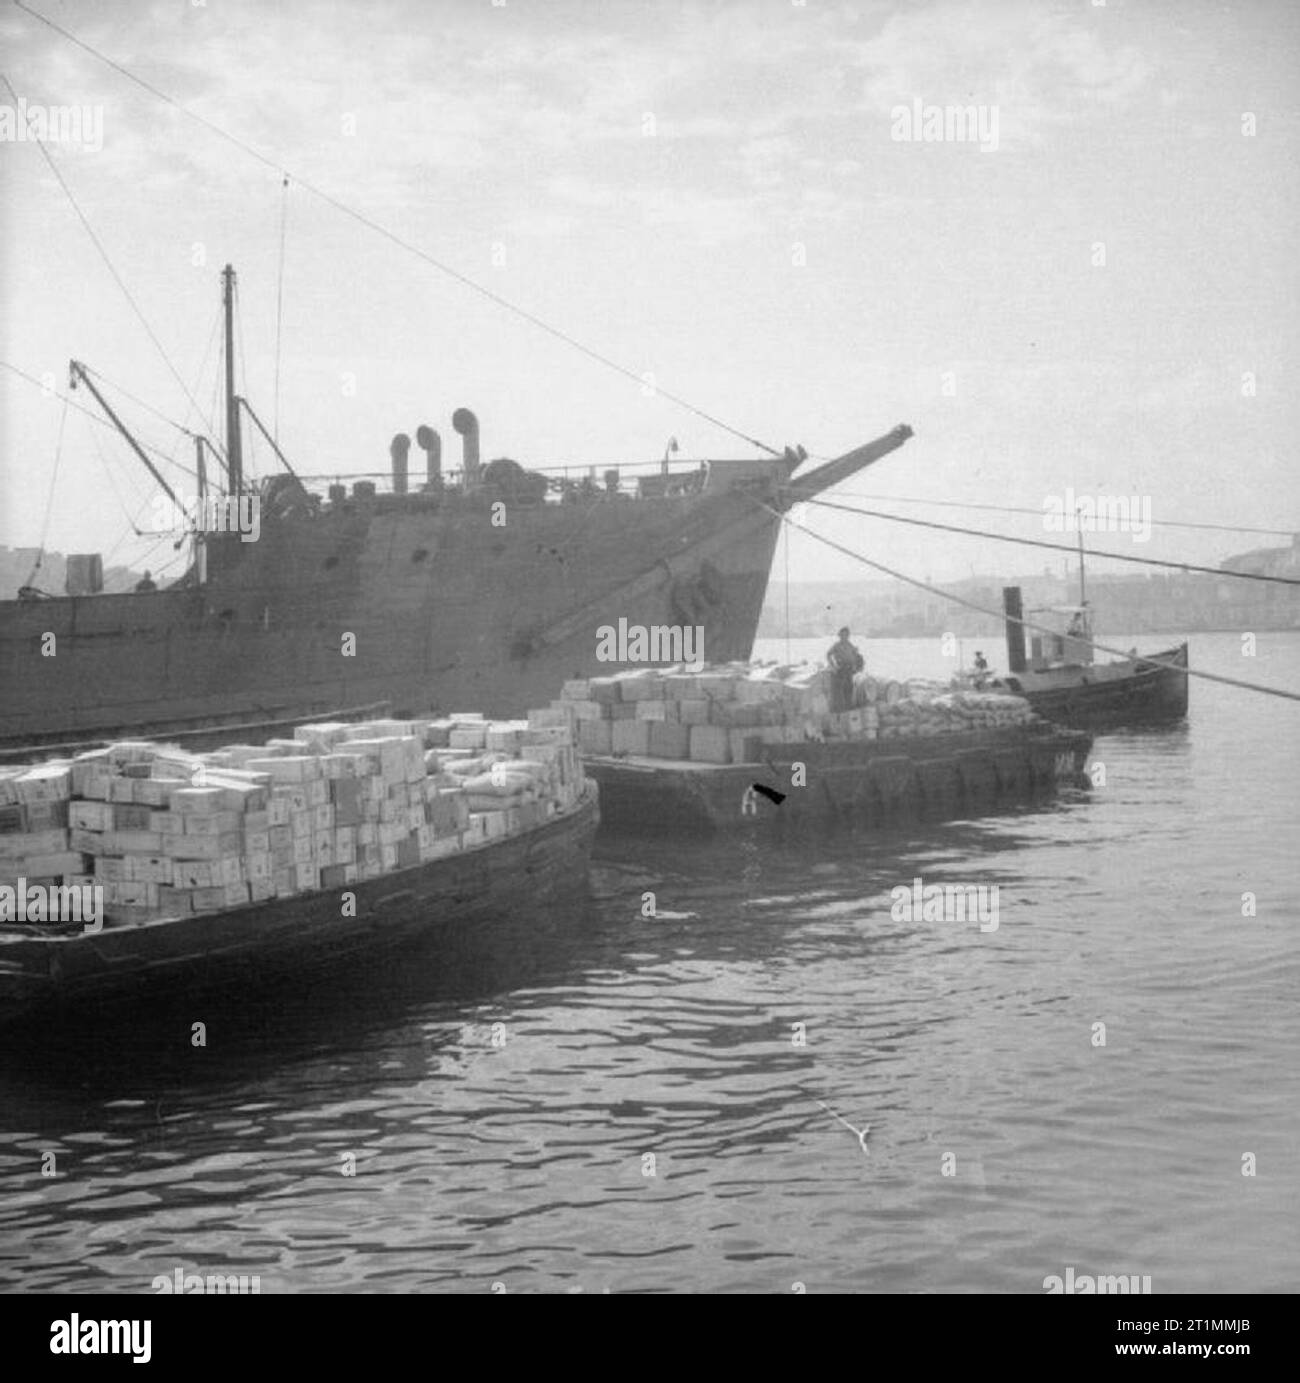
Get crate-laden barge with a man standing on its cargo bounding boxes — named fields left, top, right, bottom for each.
left=552, top=662, right=1093, bottom=831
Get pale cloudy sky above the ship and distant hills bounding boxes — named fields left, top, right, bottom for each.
left=0, top=0, right=1300, bottom=579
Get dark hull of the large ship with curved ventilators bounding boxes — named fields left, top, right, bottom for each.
left=0, top=491, right=779, bottom=747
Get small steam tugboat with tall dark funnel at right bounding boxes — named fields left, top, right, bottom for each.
left=978, top=541, right=1188, bottom=729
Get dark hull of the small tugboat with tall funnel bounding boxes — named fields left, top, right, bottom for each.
left=1008, top=643, right=1188, bottom=729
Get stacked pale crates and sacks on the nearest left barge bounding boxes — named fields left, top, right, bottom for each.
left=0, top=711, right=582, bottom=922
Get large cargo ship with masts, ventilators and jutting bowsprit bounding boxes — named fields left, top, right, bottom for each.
left=0, top=266, right=911, bottom=750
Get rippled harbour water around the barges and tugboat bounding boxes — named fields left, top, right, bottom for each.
left=0, top=633, right=1300, bottom=1294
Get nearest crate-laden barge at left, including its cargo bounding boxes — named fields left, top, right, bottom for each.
left=0, top=711, right=599, bottom=1022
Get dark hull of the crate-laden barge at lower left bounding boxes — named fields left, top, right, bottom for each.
left=0, top=784, right=599, bottom=1023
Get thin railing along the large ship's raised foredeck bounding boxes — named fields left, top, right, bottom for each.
left=284, top=461, right=709, bottom=503
